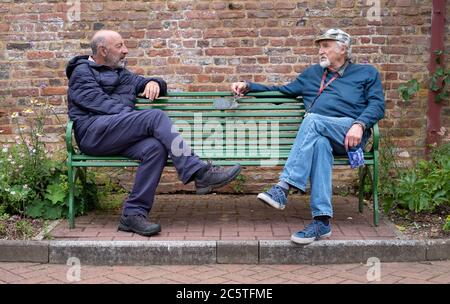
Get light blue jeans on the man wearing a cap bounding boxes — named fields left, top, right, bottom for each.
left=280, top=113, right=364, bottom=217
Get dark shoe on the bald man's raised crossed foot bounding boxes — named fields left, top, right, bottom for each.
left=195, top=162, right=241, bottom=194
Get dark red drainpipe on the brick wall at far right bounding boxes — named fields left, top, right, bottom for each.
left=425, top=0, right=446, bottom=155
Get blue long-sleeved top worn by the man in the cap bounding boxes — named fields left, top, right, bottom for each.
left=249, top=63, right=384, bottom=128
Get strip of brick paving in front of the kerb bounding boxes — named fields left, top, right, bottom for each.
left=0, top=261, right=450, bottom=284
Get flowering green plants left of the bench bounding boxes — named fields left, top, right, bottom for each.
left=0, top=100, right=96, bottom=221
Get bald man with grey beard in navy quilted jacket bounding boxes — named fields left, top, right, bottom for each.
left=66, top=30, right=240, bottom=236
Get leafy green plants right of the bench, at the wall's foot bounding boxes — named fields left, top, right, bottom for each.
left=380, top=143, right=450, bottom=213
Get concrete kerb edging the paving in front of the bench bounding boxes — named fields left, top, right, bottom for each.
left=0, top=239, right=450, bottom=265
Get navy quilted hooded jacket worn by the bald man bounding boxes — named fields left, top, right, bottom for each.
left=66, top=56, right=167, bottom=137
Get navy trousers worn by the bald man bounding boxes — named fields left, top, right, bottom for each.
left=79, top=109, right=206, bottom=216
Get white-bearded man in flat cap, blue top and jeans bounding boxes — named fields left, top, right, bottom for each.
left=231, top=29, right=384, bottom=244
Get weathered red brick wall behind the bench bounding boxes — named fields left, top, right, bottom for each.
left=0, top=0, right=450, bottom=189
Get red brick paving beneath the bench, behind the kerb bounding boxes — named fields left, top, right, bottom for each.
left=51, top=195, right=401, bottom=240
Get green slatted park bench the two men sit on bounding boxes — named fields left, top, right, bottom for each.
left=66, top=92, right=379, bottom=228
